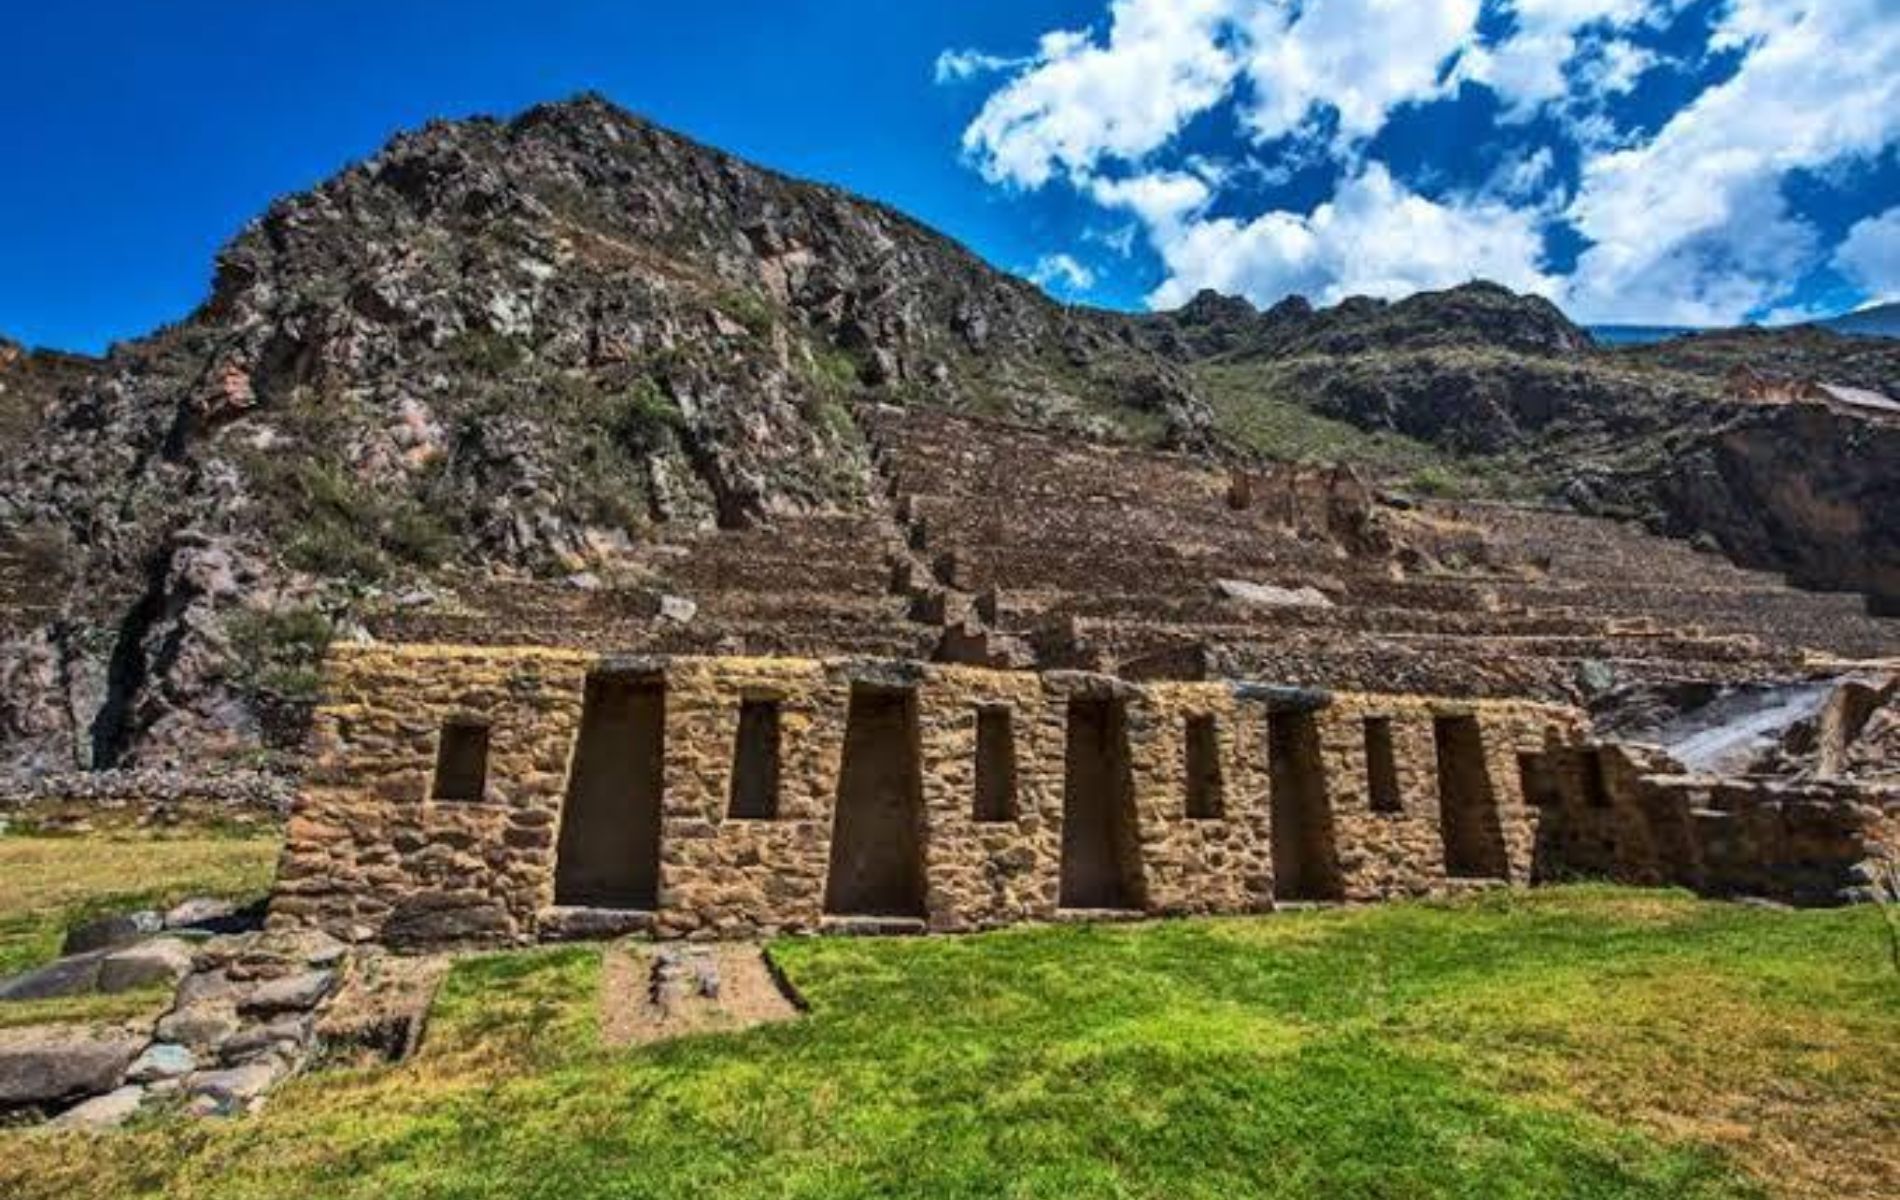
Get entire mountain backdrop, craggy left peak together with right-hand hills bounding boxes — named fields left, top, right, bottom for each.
left=0, top=97, right=1900, bottom=771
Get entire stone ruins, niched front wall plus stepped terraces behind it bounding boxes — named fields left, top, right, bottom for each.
left=272, top=410, right=1900, bottom=944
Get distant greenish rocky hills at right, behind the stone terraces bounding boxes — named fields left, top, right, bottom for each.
left=1140, top=283, right=1900, bottom=611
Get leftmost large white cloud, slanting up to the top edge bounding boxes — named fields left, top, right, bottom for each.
left=963, top=0, right=1243, bottom=188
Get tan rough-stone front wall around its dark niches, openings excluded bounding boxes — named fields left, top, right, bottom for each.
left=272, top=646, right=1583, bottom=944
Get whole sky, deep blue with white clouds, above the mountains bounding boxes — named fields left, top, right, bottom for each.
left=0, top=0, right=1900, bottom=349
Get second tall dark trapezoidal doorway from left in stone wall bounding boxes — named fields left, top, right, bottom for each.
left=825, top=687, right=923, bottom=917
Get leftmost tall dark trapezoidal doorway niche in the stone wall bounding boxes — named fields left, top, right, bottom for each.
left=555, top=676, right=667, bottom=911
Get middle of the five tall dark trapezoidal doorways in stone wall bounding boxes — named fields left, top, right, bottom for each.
left=1060, top=699, right=1146, bottom=911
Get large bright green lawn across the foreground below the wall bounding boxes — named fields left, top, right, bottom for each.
left=0, top=827, right=1900, bottom=1200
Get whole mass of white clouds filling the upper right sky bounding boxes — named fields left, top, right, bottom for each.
left=939, top=0, right=1900, bottom=323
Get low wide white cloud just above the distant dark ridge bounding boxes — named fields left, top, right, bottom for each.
left=1125, top=163, right=1556, bottom=308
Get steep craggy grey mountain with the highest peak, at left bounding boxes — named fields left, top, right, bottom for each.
left=0, top=99, right=1208, bottom=767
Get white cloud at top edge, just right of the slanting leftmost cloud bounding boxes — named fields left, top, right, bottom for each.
left=1243, top=0, right=1478, bottom=142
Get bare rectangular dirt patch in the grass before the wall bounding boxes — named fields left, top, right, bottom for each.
left=600, top=942, right=800, bottom=1046
